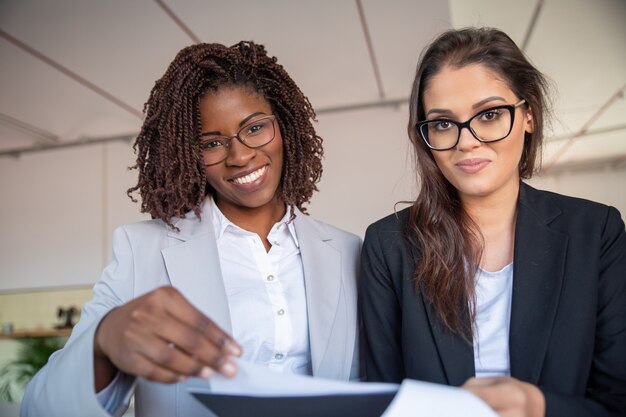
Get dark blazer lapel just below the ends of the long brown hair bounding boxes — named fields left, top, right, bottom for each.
left=416, top=296, right=475, bottom=386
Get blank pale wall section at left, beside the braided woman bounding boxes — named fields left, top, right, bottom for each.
left=0, top=143, right=142, bottom=290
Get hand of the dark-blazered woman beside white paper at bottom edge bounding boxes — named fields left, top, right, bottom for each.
left=461, top=377, right=546, bottom=417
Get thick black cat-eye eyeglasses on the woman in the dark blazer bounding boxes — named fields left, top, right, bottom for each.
left=415, top=99, right=526, bottom=151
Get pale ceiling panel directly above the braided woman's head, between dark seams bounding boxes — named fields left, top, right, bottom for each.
left=168, top=0, right=377, bottom=107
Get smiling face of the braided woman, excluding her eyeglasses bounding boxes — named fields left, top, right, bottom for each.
left=199, top=87, right=283, bottom=215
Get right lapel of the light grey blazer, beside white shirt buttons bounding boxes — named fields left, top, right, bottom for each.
left=294, top=212, right=350, bottom=377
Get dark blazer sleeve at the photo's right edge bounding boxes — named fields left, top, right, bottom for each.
left=539, top=207, right=626, bottom=417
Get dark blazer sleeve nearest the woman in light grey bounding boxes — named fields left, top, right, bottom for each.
left=360, top=224, right=404, bottom=382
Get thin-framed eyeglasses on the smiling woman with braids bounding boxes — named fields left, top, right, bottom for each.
left=200, top=115, right=276, bottom=165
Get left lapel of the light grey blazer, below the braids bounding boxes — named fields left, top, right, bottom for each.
left=161, top=198, right=232, bottom=333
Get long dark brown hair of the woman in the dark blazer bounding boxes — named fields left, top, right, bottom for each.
left=404, top=28, right=548, bottom=341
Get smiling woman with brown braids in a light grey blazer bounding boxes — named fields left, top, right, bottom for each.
left=22, top=42, right=361, bottom=417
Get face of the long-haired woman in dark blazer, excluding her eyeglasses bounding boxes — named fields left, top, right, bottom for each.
left=423, top=64, right=533, bottom=201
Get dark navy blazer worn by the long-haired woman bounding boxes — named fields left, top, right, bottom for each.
left=361, top=184, right=626, bottom=417
